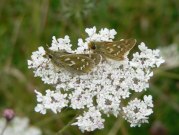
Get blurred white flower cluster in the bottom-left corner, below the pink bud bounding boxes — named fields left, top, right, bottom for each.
left=0, top=117, right=42, bottom=135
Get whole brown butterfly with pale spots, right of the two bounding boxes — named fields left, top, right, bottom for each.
left=88, top=38, right=136, bottom=61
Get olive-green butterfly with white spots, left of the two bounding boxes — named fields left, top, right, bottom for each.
left=46, top=49, right=102, bottom=74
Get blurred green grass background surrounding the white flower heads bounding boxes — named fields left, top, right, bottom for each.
left=0, top=0, right=179, bottom=135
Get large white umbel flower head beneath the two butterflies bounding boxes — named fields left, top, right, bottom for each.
left=28, top=27, right=164, bottom=132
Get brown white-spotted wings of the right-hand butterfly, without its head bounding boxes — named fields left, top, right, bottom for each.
left=99, top=39, right=136, bottom=60
